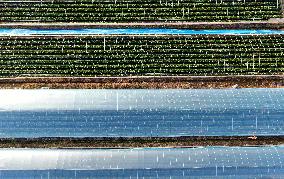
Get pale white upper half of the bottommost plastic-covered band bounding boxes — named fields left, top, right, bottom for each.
left=0, top=147, right=284, bottom=170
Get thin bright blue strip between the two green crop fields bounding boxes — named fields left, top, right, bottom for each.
left=0, top=28, right=284, bottom=36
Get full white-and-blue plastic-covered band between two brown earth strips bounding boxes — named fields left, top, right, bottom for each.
left=0, top=88, right=284, bottom=138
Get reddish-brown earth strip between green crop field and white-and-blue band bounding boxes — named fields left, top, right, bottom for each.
left=0, top=75, right=284, bottom=89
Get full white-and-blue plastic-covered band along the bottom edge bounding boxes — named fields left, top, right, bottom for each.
left=0, top=146, right=284, bottom=178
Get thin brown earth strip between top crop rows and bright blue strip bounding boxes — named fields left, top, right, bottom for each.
left=0, top=18, right=284, bottom=30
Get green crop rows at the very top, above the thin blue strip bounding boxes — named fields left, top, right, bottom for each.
left=0, top=0, right=281, bottom=22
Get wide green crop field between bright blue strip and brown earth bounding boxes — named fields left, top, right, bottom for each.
left=0, top=35, right=284, bottom=77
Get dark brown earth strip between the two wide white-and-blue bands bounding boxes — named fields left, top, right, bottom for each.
left=0, top=136, right=284, bottom=148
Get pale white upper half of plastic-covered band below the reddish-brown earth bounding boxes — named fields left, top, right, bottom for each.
left=0, top=88, right=284, bottom=111
